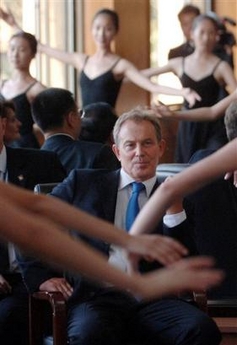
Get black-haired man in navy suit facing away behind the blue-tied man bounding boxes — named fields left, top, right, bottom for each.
left=32, top=88, right=119, bottom=173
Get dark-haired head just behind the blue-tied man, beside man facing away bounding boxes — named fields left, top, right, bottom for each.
left=79, top=102, right=118, bottom=146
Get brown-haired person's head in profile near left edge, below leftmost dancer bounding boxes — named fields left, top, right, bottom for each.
left=2, top=101, right=21, bottom=145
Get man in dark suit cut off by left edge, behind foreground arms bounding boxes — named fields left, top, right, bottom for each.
left=0, top=103, right=65, bottom=345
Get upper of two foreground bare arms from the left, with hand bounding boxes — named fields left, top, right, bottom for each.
left=0, top=183, right=187, bottom=265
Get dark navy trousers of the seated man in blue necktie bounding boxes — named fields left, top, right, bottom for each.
left=68, top=291, right=221, bottom=345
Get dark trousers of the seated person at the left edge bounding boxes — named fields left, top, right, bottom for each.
left=0, top=274, right=29, bottom=345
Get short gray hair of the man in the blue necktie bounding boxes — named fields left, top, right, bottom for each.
left=113, top=106, right=162, bottom=146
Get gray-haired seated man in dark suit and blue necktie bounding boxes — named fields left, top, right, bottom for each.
left=18, top=109, right=220, bottom=345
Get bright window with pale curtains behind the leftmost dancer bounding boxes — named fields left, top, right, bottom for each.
left=0, top=0, right=81, bottom=96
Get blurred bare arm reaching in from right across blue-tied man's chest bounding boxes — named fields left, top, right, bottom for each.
left=130, top=139, right=237, bottom=234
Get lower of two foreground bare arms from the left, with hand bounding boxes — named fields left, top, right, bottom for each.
left=0, top=183, right=223, bottom=298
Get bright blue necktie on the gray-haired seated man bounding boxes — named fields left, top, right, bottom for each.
left=125, top=182, right=145, bottom=231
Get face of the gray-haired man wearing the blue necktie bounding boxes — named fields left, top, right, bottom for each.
left=113, top=120, right=165, bottom=181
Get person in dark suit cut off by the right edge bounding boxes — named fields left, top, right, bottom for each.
left=188, top=101, right=237, bottom=299
